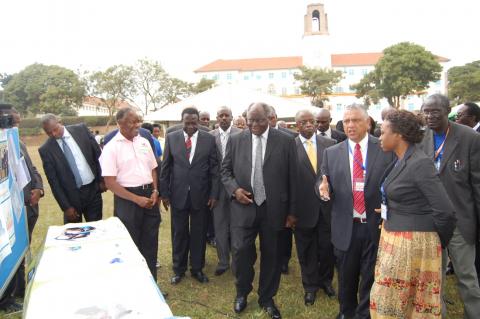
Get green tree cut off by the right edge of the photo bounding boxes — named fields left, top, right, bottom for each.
left=448, top=60, right=480, bottom=104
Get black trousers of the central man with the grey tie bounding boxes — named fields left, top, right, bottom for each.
left=231, top=203, right=280, bottom=306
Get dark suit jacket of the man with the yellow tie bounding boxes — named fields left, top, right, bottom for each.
left=295, top=134, right=335, bottom=228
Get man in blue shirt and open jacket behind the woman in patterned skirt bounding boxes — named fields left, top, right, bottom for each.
left=421, top=94, right=480, bottom=318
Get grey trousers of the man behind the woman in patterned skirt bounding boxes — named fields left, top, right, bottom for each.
left=442, top=228, right=480, bottom=319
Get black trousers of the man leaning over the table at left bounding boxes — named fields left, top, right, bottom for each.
left=63, top=181, right=103, bottom=224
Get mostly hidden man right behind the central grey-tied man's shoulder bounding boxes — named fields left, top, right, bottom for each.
left=268, top=105, right=298, bottom=275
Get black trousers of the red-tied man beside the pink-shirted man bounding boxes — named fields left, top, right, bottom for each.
left=171, top=194, right=208, bottom=275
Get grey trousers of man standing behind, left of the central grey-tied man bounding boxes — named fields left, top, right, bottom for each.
left=213, top=187, right=230, bottom=269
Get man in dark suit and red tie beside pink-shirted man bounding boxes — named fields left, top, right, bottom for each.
left=160, top=107, right=219, bottom=284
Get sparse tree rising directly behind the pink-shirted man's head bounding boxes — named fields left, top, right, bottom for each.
left=88, top=64, right=137, bottom=128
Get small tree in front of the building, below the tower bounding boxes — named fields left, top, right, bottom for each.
left=294, top=66, right=343, bottom=107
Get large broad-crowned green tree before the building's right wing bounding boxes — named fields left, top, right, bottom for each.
left=351, top=42, right=442, bottom=108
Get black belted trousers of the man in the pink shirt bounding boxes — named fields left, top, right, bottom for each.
left=113, top=188, right=161, bottom=281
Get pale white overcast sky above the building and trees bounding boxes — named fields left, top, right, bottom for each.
left=0, top=0, right=480, bottom=80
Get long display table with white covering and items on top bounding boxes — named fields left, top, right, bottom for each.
left=24, top=217, right=186, bottom=319
